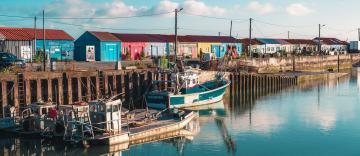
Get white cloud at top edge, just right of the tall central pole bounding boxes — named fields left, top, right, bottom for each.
left=181, top=0, right=226, bottom=15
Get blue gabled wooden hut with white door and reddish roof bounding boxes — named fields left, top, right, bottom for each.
left=75, top=31, right=121, bottom=62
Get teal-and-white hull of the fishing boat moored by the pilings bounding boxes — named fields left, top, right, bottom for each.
left=147, top=80, right=230, bottom=109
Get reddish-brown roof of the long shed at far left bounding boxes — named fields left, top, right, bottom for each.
left=0, top=27, right=74, bottom=41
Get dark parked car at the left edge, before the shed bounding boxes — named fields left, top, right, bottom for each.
left=0, top=52, right=25, bottom=69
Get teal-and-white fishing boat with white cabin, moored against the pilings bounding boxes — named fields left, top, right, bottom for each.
left=146, top=67, right=230, bottom=109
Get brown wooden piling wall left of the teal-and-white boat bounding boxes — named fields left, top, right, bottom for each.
left=0, top=69, right=172, bottom=118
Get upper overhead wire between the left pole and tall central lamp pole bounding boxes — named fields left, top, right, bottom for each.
left=45, top=11, right=175, bottom=20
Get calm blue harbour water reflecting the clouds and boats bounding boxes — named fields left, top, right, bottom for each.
left=0, top=71, right=360, bottom=156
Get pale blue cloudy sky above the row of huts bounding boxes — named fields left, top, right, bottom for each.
left=0, top=0, right=360, bottom=41
